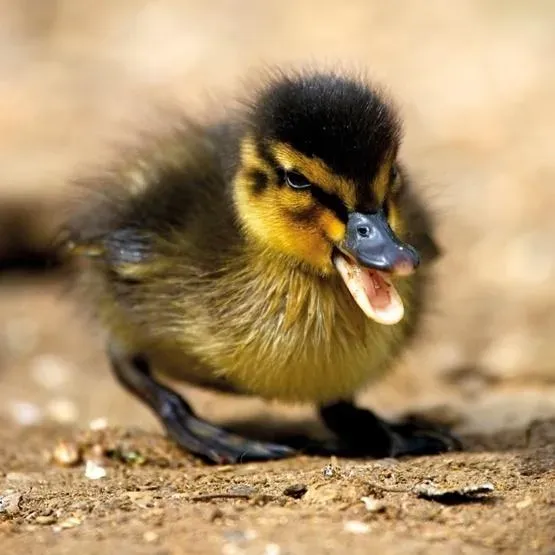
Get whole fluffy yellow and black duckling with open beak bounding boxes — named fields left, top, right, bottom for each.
left=65, top=71, right=459, bottom=463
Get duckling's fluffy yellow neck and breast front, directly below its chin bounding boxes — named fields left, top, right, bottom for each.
left=199, top=240, right=412, bottom=402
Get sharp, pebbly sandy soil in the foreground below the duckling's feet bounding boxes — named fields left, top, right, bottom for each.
left=0, top=421, right=555, bottom=555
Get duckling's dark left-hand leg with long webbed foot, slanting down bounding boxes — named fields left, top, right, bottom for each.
left=108, top=343, right=300, bottom=464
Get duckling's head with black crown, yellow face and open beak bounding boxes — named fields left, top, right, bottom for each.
left=234, top=73, right=436, bottom=324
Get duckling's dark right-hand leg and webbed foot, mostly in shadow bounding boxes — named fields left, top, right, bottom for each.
left=320, top=401, right=462, bottom=458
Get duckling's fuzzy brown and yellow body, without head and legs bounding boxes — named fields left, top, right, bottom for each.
left=62, top=71, right=444, bottom=403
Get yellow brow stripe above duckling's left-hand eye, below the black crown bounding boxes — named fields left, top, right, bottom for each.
left=270, top=143, right=356, bottom=209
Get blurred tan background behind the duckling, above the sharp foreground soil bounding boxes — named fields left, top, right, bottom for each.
left=0, top=0, right=555, bottom=444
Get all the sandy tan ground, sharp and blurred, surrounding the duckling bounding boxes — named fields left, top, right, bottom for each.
left=0, top=0, right=555, bottom=555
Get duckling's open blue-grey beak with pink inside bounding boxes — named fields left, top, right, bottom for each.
left=334, top=211, right=420, bottom=325
